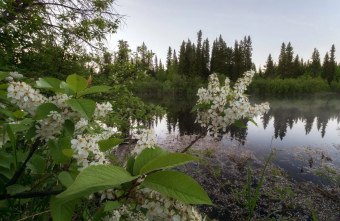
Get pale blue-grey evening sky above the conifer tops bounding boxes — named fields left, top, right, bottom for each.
left=108, top=0, right=340, bottom=68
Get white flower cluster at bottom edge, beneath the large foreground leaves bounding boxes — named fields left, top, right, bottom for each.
left=104, top=188, right=205, bottom=221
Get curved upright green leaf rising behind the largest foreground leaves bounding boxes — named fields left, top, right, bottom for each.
left=133, top=146, right=167, bottom=175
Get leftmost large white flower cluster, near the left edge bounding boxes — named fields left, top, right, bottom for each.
left=7, top=82, right=48, bottom=115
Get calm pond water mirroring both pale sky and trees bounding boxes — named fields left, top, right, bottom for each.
left=140, top=94, right=340, bottom=180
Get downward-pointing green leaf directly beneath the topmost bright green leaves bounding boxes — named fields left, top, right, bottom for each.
left=66, top=99, right=96, bottom=120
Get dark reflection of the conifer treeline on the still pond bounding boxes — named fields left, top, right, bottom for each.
left=140, top=94, right=340, bottom=142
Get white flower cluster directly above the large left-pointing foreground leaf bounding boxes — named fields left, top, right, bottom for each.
left=71, top=130, right=113, bottom=171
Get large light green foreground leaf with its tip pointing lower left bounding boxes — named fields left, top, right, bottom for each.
left=57, top=165, right=136, bottom=200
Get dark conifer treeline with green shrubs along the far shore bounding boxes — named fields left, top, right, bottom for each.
left=131, top=31, right=340, bottom=93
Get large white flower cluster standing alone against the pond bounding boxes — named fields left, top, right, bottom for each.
left=196, top=71, right=269, bottom=136
